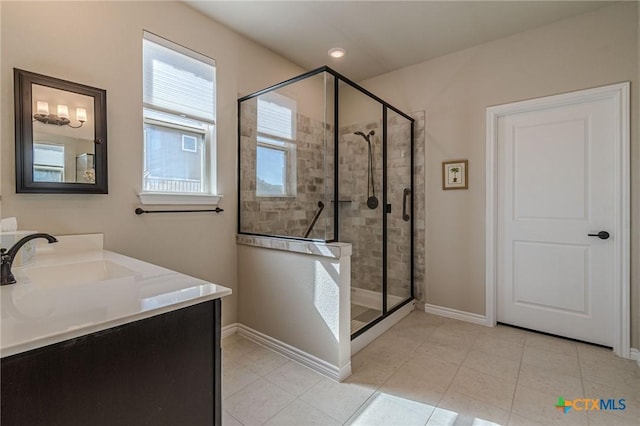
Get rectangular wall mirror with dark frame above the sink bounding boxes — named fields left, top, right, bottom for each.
left=13, top=68, right=108, bottom=194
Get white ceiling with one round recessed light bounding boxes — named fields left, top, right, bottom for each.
left=186, top=1, right=611, bottom=81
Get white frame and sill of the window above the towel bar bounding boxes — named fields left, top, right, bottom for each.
left=138, top=31, right=222, bottom=206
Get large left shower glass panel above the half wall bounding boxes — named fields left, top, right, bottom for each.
left=238, top=73, right=334, bottom=240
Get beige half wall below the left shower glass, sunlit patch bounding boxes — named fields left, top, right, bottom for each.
left=238, top=238, right=351, bottom=375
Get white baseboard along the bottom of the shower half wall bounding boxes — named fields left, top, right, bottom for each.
left=237, top=324, right=351, bottom=382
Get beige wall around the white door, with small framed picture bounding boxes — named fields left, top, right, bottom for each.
left=362, top=2, right=640, bottom=348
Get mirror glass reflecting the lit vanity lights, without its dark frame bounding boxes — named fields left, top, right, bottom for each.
left=31, top=83, right=95, bottom=184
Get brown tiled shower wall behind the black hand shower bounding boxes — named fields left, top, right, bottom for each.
left=339, top=111, right=425, bottom=306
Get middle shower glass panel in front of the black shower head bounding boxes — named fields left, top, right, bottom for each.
left=338, top=82, right=384, bottom=333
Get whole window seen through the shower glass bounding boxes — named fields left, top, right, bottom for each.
left=256, top=92, right=296, bottom=197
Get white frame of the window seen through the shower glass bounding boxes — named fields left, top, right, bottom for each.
left=256, top=92, right=298, bottom=198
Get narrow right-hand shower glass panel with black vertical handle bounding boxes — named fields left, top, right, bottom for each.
left=385, top=109, right=413, bottom=310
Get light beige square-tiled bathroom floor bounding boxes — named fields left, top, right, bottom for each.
left=222, top=311, right=640, bottom=426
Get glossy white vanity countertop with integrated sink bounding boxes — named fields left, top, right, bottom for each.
left=0, top=234, right=231, bottom=357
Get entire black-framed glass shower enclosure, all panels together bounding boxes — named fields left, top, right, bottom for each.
left=238, top=67, right=414, bottom=338
